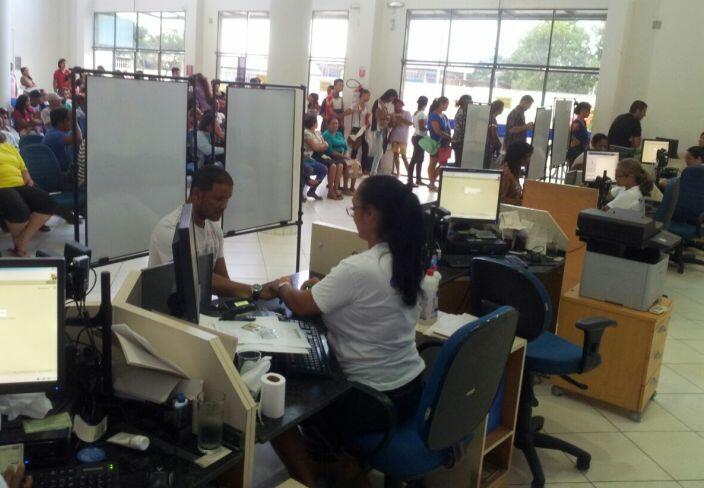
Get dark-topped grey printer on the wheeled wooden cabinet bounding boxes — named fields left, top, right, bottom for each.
left=577, top=208, right=680, bottom=310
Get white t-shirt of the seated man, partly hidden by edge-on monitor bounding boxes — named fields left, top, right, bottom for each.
left=149, top=207, right=225, bottom=268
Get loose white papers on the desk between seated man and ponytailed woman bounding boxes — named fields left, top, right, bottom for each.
left=200, top=316, right=310, bottom=354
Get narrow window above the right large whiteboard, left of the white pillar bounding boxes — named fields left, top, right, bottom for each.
left=217, top=12, right=269, bottom=82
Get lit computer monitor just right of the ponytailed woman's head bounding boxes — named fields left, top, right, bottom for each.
left=438, top=168, right=501, bottom=223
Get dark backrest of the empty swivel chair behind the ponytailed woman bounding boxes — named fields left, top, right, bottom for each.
left=470, top=258, right=553, bottom=341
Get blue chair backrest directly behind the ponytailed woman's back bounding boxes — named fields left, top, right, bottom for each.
left=416, top=307, right=518, bottom=451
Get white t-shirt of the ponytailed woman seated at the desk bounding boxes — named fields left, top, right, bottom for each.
left=312, top=243, right=425, bottom=391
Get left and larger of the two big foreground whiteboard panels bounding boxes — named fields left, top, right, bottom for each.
left=86, top=76, right=188, bottom=261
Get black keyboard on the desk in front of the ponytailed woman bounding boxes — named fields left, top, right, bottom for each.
left=271, top=321, right=333, bottom=378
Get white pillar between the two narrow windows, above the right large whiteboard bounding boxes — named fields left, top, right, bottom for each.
left=266, top=0, right=313, bottom=85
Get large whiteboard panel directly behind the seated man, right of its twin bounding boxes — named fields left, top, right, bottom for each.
left=223, top=86, right=303, bottom=234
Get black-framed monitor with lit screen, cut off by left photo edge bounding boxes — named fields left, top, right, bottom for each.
left=0, top=258, right=65, bottom=394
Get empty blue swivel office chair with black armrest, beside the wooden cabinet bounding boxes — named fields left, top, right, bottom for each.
left=470, top=258, right=616, bottom=488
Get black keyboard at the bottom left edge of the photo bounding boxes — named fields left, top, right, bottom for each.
left=29, top=463, right=120, bottom=488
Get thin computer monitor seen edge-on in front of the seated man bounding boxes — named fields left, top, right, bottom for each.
left=171, top=203, right=200, bottom=324
